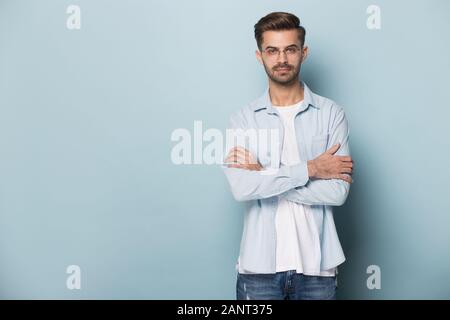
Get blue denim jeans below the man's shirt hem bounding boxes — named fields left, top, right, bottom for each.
left=236, top=270, right=337, bottom=300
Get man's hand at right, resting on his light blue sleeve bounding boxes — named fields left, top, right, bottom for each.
left=308, top=143, right=353, bottom=183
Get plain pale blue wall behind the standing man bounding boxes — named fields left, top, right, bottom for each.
left=0, top=0, right=450, bottom=299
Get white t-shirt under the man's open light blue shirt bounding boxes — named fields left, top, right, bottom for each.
left=238, top=100, right=337, bottom=276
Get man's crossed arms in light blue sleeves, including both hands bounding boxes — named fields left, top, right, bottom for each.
left=223, top=109, right=353, bottom=206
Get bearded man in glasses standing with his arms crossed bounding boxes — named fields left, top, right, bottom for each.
left=223, top=12, right=353, bottom=299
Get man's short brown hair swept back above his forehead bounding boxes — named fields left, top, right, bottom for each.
left=255, top=12, right=306, bottom=50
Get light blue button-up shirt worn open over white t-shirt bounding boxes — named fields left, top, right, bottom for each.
left=222, top=82, right=350, bottom=273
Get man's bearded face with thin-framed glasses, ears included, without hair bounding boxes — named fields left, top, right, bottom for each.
left=256, top=29, right=308, bottom=85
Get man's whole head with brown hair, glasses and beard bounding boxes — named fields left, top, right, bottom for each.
left=255, top=12, right=308, bottom=85
